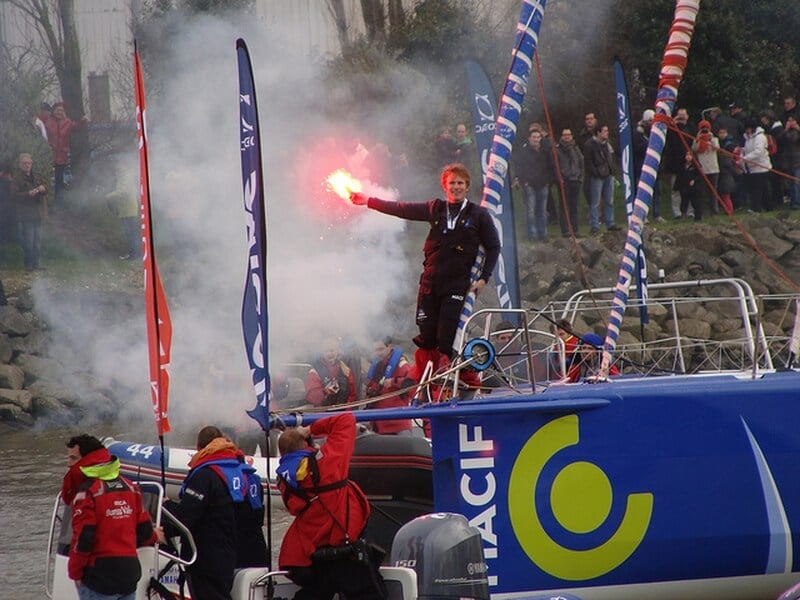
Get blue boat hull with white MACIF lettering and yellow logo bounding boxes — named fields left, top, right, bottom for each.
left=430, top=372, right=800, bottom=597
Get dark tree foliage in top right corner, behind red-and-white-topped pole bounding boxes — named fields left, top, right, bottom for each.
left=611, top=0, right=800, bottom=116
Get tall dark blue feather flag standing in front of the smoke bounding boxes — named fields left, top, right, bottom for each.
left=236, top=39, right=270, bottom=430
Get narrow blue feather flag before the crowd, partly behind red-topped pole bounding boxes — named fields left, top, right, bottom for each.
left=614, top=58, right=650, bottom=325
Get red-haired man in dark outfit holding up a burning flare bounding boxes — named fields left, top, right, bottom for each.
left=350, top=163, right=500, bottom=384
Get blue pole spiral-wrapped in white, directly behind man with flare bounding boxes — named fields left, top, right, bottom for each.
left=453, top=0, right=546, bottom=352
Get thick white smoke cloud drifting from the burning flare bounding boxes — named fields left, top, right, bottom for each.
left=39, top=9, right=435, bottom=429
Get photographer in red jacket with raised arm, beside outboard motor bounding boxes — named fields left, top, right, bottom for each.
left=278, top=412, right=386, bottom=600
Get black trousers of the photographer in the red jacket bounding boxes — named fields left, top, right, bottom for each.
left=289, top=559, right=386, bottom=600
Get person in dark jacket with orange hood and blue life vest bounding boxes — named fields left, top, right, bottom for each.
left=167, top=425, right=266, bottom=600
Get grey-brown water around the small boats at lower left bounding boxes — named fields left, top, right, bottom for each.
left=0, top=425, right=291, bottom=600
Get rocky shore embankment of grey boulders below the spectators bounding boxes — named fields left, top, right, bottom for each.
left=0, top=212, right=800, bottom=427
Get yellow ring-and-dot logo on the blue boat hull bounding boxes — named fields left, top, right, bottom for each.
left=508, top=415, right=653, bottom=581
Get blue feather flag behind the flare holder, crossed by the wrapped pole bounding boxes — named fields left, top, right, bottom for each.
left=466, top=60, right=522, bottom=322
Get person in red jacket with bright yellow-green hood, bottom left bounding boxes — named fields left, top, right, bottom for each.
left=62, top=434, right=164, bottom=600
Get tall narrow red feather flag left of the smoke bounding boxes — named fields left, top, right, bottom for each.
left=133, top=47, right=172, bottom=436
